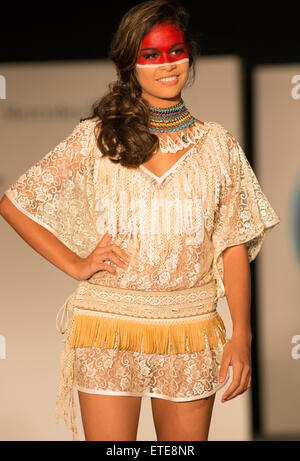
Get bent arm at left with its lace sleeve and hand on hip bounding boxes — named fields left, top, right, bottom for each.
left=0, top=121, right=131, bottom=281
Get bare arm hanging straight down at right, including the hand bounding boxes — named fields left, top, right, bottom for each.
left=220, top=244, right=252, bottom=402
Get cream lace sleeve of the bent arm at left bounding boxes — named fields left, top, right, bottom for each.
left=4, top=120, right=97, bottom=257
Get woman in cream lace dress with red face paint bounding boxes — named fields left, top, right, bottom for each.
left=1, top=0, right=279, bottom=440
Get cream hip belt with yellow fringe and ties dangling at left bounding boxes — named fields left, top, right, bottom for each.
left=56, top=281, right=226, bottom=440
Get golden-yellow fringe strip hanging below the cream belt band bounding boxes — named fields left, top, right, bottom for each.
left=71, top=314, right=226, bottom=354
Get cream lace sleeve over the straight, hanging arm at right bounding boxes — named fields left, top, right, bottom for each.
left=212, top=125, right=280, bottom=298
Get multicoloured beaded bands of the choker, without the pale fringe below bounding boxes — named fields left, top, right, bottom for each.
left=149, top=99, right=195, bottom=133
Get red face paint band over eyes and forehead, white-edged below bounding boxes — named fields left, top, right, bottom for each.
left=136, top=23, right=189, bottom=68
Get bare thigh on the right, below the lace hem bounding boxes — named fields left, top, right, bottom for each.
left=151, top=394, right=215, bottom=441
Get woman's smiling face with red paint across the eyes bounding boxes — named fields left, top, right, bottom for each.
left=135, top=23, right=189, bottom=107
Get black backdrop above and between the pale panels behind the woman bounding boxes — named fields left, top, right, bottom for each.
left=0, top=0, right=300, bottom=439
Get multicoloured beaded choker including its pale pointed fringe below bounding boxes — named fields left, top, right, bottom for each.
left=148, top=98, right=203, bottom=154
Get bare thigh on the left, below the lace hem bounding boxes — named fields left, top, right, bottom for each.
left=78, top=391, right=142, bottom=441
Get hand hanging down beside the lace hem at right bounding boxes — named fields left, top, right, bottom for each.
left=219, top=335, right=251, bottom=403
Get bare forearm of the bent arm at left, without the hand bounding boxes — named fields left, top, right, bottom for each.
left=0, top=195, right=80, bottom=279
